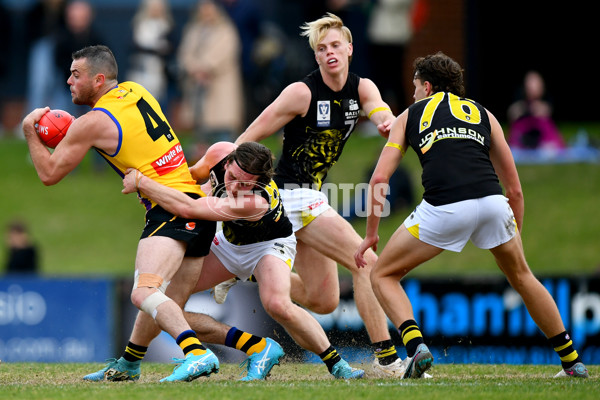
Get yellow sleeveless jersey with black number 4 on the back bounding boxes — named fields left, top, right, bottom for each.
left=93, top=82, right=205, bottom=210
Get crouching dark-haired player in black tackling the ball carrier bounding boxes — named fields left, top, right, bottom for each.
left=123, top=142, right=364, bottom=380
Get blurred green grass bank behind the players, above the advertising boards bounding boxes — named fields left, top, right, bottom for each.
left=0, top=123, right=600, bottom=277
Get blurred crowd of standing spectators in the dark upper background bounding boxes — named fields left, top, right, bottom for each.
left=0, top=0, right=420, bottom=153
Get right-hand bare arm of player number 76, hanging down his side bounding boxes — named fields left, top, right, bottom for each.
left=486, top=110, right=525, bottom=231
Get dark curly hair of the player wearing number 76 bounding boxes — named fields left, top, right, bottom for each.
left=413, top=51, right=465, bottom=97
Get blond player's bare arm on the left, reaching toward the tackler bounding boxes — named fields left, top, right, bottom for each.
left=235, top=82, right=311, bottom=144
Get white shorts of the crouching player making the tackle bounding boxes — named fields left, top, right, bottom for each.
left=210, top=231, right=296, bottom=281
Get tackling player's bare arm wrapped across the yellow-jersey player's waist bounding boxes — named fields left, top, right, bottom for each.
left=122, top=169, right=269, bottom=221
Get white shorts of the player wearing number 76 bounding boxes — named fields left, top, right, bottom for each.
left=404, top=195, right=517, bottom=252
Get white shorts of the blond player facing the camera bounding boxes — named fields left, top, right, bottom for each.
left=279, top=188, right=331, bottom=232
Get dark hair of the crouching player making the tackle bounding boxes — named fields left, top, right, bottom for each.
left=226, top=142, right=275, bottom=186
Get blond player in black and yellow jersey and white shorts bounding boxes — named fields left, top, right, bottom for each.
left=217, top=13, right=410, bottom=376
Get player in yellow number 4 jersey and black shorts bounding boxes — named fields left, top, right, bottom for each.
left=22, top=46, right=225, bottom=381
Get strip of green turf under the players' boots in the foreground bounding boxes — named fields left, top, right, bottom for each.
left=0, top=361, right=600, bottom=400
